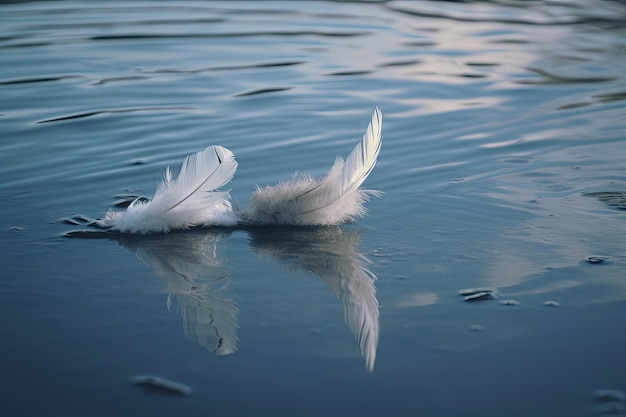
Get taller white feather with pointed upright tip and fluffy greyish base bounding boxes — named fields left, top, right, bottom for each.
left=238, top=108, right=382, bottom=225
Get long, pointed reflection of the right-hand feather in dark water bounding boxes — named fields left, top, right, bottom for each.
left=249, top=227, right=380, bottom=372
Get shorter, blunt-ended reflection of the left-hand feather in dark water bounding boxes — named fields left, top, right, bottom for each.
left=117, top=230, right=239, bottom=355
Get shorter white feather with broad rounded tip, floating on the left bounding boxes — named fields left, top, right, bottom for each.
left=97, top=146, right=237, bottom=234
